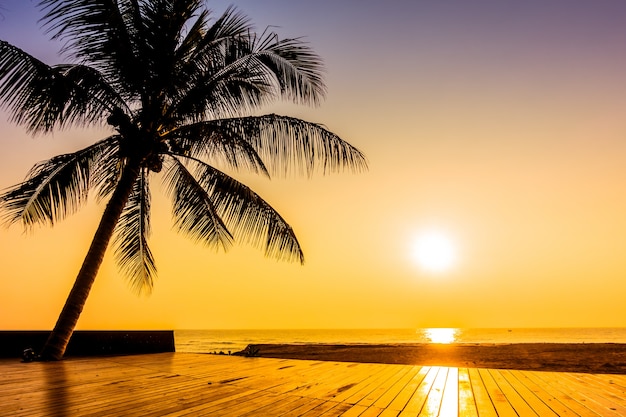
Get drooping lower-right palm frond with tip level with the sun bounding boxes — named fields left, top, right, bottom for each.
left=177, top=156, right=304, bottom=263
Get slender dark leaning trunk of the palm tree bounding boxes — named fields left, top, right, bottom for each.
left=40, top=161, right=139, bottom=360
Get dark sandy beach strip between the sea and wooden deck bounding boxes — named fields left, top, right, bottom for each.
left=238, top=343, right=626, bottom=374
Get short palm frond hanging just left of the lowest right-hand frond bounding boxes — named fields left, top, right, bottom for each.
left=164, top=158, right=232, bottom=250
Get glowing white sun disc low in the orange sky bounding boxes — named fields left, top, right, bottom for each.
left=412, top=231, right=456, bottom=272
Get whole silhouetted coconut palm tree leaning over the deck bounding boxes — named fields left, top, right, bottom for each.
left=0, top=0, right=366, bottom=360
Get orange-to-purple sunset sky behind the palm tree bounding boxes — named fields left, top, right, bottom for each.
left=0, top=0, right=626, bottom=329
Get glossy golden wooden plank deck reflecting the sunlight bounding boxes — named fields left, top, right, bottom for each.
left=0, top=353, right=626, bottom=417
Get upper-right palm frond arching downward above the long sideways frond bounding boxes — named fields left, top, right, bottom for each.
left=170, top=32, right=326, bottom=120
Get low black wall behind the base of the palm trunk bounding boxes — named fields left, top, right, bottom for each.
left=0, top=330, right=176, bottom=358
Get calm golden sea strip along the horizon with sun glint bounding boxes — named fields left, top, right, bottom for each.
left=174, top=328, right=626, bottom=353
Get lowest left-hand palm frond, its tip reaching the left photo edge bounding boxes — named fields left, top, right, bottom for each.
left=0, top=140, right=112, bottom=227
